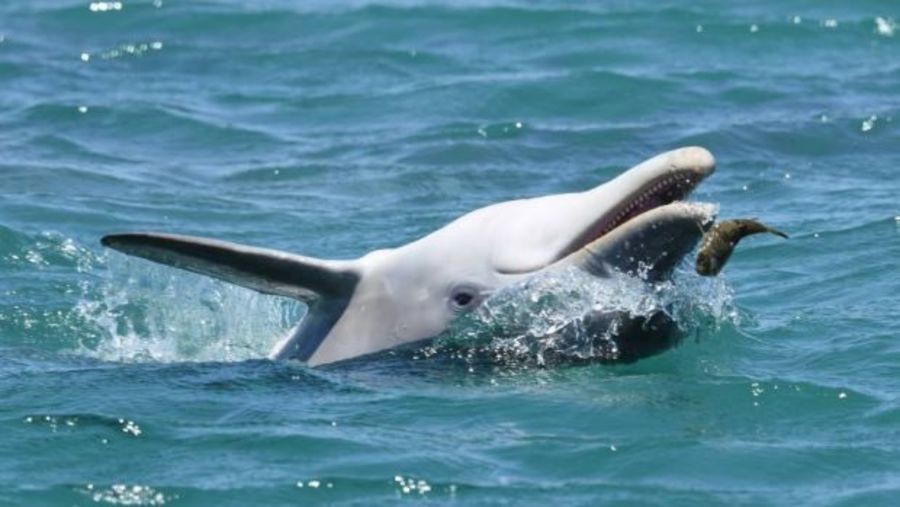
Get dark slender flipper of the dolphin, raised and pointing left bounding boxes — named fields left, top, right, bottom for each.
left=100, top=233, right=359, bottom=302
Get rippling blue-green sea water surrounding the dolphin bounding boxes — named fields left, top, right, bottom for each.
left=0, top=0, right=900, bottom=506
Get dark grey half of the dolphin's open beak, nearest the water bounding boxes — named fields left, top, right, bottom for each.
left=560, top=202, right=713, bottom=281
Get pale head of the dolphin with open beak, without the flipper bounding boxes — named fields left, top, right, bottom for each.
left=296, top=148, right=715, bottom=365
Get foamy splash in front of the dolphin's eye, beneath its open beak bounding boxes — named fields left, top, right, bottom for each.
left=436, top=257, right=739, bottom=365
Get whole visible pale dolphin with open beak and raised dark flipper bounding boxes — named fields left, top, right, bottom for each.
left=102, top=147, right=715, bottom=366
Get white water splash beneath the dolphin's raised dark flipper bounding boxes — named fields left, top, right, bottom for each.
left=73, top=254, right=303, bottom=362
